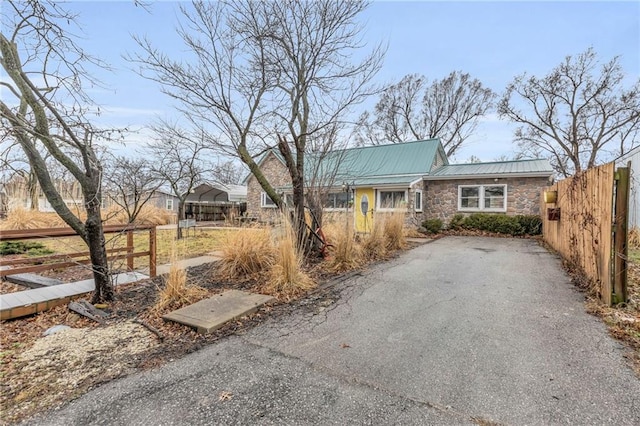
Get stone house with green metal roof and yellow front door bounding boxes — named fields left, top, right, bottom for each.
left=245, top=139, right=553, bottom=232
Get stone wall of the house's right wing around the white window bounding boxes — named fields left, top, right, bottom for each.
left=422, top=178, right=549, bottom=224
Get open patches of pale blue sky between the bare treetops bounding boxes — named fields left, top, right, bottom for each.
left=55, top=1, right=640, bottom=161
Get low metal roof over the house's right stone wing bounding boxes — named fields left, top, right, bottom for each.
left=427, top=159, right=553, bottom=179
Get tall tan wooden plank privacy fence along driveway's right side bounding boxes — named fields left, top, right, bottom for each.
left=541, top=163, right=629, bottom=305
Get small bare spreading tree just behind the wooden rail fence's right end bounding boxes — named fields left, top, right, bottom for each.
left=104, top=156, right=162, bottom=223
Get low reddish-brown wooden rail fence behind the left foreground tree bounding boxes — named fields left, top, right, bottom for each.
left=0, top=225, right=156, bottom=277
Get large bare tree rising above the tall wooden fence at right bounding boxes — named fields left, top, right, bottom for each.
left=498, top=48, right=640, bottom=176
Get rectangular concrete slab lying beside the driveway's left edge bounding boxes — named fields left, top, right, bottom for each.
left=162, top=290, right=274, bottom=334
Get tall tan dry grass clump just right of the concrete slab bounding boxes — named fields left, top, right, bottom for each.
left=265, top=217, right=315, bottom=299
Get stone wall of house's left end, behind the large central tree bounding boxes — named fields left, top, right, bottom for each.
left=247, top=153, right=291, bottom=221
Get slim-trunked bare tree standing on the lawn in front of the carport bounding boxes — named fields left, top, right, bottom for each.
left=146, top=122, right=207, bottom=239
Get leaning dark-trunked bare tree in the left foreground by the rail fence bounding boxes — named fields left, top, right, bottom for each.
left=0, top=1, right=114, bottom=302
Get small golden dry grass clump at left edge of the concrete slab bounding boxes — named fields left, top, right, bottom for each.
left=152, top=249, right=209, bottom=314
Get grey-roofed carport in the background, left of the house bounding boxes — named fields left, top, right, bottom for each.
left=185, top=182, right=247, bottom=221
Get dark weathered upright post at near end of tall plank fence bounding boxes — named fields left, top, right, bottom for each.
left=611, top=167, right=630, bottom=304
